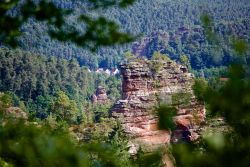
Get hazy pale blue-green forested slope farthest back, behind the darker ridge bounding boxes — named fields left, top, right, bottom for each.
left=16, top=0, right=250, bottom=69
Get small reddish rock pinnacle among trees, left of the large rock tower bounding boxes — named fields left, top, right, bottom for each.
left=91, top=86, right=109, bottom=104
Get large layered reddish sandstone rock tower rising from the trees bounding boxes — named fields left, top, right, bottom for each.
left=112, top=60, right=205, bottom=149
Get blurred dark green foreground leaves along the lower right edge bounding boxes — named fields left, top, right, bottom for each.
left=173, top=65, right=250, bottom=167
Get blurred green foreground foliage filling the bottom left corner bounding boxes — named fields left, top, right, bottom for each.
left=0, top=120, right=86, bottom=166
